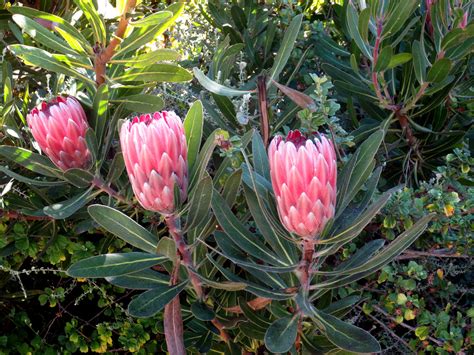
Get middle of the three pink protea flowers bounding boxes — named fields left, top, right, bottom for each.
left=120, top=111, right=188, bottom=215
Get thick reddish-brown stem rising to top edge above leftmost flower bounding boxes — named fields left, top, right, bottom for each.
left=94, top=0, right=137, bottom=86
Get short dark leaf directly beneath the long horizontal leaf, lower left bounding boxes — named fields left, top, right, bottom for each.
left=105, top=269, right=170, bottom=290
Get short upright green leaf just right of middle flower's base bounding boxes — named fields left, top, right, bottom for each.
left=185, top=173, right=214, bottom=230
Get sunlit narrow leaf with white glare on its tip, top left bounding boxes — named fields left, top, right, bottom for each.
left=12, top=14, right=79, bottom=56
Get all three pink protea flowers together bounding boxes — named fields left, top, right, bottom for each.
left=27, top=96, right=337, bottom=239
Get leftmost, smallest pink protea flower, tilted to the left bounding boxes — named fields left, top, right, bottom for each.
left=26, top=96, right=91, bottom=170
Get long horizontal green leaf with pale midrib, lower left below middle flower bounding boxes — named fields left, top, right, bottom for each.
left=67, top=252, right=168, bottom=279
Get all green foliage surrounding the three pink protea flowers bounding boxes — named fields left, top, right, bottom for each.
left=0, top=0, right=474, bottom=354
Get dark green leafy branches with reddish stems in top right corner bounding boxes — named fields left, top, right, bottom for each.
left=313, top=0, right=474, bottom=182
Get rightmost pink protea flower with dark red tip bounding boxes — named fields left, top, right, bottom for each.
left=268, top=130, right=337, bottom=239
